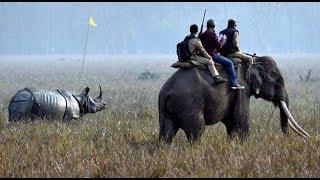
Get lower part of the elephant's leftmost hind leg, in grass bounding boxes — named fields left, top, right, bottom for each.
left=159, top=117, right=179, bottom=144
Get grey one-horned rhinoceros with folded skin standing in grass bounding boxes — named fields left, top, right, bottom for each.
left=9, top=86, right=106, bottom=122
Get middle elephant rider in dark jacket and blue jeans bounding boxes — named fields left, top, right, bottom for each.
left=200, top=19, right=244, bottom=89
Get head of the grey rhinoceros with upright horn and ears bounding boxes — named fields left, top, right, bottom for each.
left=75, top=85, right=106, bottom=114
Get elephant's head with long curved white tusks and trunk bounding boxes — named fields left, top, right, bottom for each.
left=247, top=56, right=310, bottom=137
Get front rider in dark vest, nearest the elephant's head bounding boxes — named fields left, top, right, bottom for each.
left=219, top=19, right=253, bottom=66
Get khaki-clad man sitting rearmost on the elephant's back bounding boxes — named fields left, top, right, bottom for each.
left=186, top=24, right=227, bottom=84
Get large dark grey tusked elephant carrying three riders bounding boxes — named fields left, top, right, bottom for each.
left=158, top=56, right=310, bottom=144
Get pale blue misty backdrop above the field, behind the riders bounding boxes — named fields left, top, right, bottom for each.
left=0, top=2, right=320, bottom=55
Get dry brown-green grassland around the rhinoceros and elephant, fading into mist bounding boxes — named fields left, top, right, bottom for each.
left=0, top=56, right=320, bottom=177
